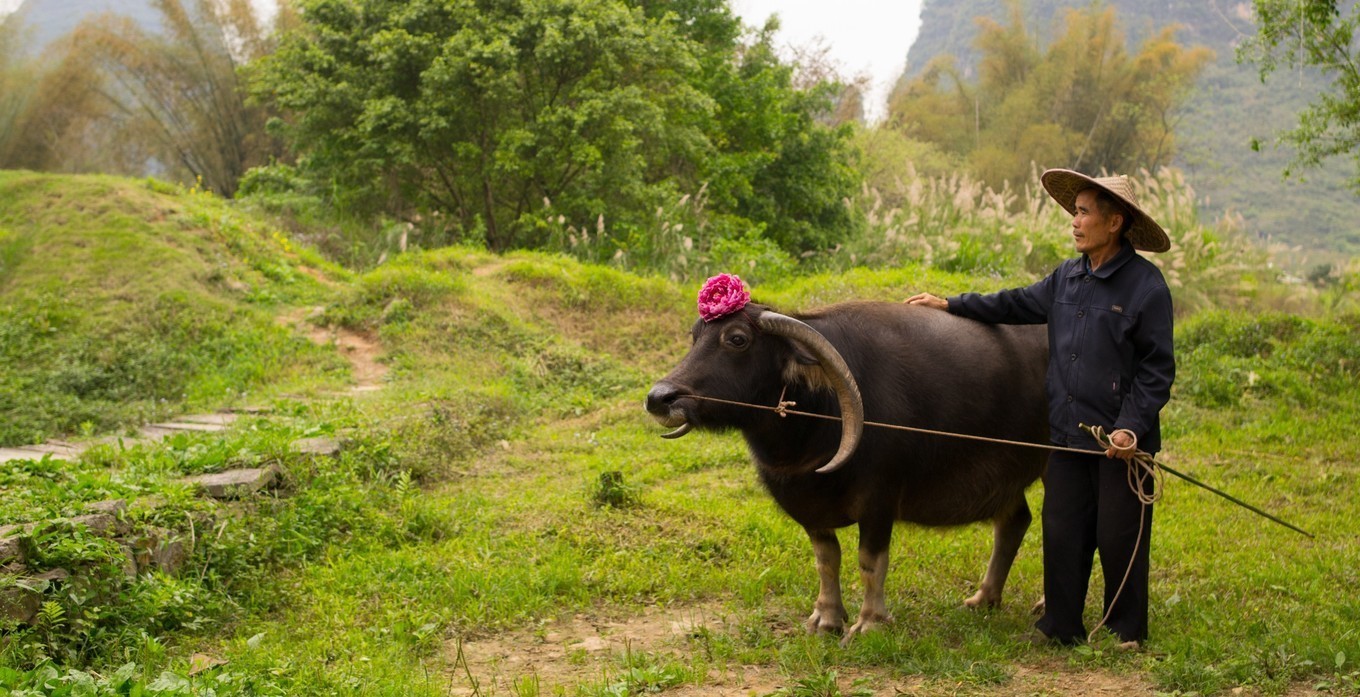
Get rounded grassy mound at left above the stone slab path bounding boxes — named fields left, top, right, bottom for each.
left=0, top=172, right=345, bottom=447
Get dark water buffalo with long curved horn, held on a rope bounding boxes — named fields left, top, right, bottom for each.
left=646, top=302, right=1049, bottom=641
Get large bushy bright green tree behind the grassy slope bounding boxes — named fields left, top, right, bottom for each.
left=256, top=0, right=843, bottom=250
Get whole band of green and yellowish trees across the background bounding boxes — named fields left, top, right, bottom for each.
left=0, top=0, right=1343, bottom=276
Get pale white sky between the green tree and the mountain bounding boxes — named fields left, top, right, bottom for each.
left=0, top=0, right=922, bottom=120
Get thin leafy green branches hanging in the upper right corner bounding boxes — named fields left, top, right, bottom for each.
left=1238, top=0, right=1360, bottom=191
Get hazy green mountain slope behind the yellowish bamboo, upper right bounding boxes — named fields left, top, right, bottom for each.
left=907, top=0, right=1360, bottom=265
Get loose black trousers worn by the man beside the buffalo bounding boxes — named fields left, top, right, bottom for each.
left=1035, top=452, right=1152, bottom=644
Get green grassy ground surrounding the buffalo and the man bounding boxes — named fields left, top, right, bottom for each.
left=0, top=174, right=1360, bottom=694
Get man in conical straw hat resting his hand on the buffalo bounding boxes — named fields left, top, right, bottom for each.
left=906, top=169, right=1175, bottom=649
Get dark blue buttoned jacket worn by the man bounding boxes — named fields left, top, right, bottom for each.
left=948, top=241, right=1176, bottom=453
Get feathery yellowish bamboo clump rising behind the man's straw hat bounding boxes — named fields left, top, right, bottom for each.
left=888, top=4, right=1210, bottom=188
